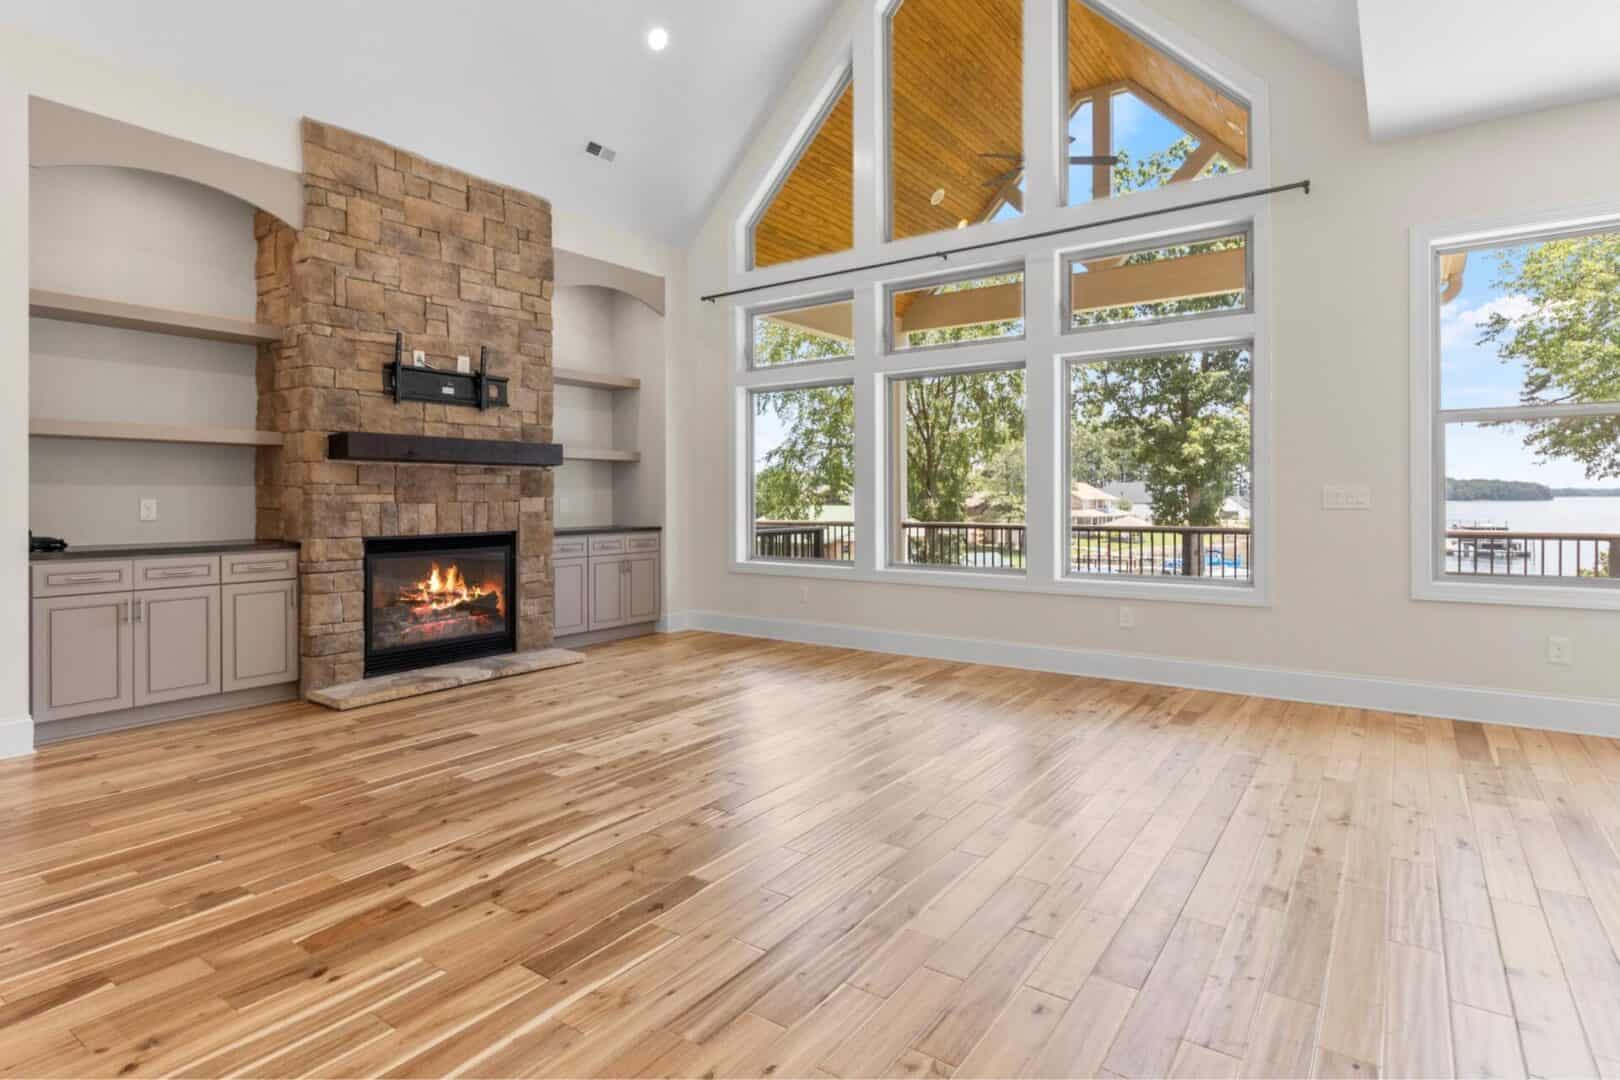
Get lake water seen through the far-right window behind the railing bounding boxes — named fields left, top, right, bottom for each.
left=1445, top=495, right=1620, bottom=576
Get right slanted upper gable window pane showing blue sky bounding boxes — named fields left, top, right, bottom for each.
left=1066, top=0, right=1249, bottom=206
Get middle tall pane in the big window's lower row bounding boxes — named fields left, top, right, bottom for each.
left=889, top=369, right=1027, bottom=573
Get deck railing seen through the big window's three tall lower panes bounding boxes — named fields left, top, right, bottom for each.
left=753, top=521, right=1254, bottom=581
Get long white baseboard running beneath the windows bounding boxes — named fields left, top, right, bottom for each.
left=659, top=610, right=1620, bottom=737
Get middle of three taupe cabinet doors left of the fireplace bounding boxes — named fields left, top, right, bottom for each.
left=131, top=585, right=220, bottom=704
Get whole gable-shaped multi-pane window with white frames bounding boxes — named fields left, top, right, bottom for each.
left=732, top=0, right=1263, bottom=605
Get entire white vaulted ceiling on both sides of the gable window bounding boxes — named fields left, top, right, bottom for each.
left=9, top=0, right=1620, bottom=244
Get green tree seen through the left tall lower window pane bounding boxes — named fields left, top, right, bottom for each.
left=753, top=385, right=855, bottom=521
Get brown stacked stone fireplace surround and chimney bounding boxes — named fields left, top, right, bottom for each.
left=254, top=120, right=552, bottom=693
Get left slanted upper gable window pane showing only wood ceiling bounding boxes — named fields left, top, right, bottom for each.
left=748, top=76, right=855, bottom=267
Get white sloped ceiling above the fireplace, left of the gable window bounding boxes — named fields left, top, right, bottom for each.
left=0, top=0, right=838, bottom=244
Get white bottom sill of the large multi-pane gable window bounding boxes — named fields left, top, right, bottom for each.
left=731, top=560, right=1270, bottom=607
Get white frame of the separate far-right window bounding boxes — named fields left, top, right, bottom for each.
left=1409, top=201, right=1620, bottom=610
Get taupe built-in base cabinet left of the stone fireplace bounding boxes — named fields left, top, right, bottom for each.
left=32, top=551, right=298, bottom=724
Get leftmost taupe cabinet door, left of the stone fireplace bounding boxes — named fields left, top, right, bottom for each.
left=32, top=593, right=134, bottom=724
